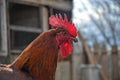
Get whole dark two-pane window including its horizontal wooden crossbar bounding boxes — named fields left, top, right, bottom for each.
left=9, top=3, right=42, bottom=53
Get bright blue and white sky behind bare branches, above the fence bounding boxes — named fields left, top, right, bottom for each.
left=73, top=0, right=120, bottom=45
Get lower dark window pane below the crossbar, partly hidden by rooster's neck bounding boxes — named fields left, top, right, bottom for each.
left=10, top=30, right=39, bottom=50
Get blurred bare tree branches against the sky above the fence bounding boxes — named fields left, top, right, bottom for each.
left=75, top=0, right=120, bottom=45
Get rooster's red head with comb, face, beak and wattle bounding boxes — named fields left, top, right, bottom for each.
left=49, top=14, right=77, bottom=57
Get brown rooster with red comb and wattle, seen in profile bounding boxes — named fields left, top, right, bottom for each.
left=0, top=14, right=77, bottom=80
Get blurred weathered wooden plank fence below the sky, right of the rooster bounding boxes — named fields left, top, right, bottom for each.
left=56, top=46, right=120, bottom=80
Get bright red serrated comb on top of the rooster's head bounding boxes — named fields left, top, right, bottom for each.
left=49, top=14, right=77, bottom=36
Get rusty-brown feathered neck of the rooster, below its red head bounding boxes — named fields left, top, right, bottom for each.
left=9, top=29, right=58, bottom=80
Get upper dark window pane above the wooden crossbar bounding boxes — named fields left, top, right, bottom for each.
left=9, top=3, right=41, bottom=28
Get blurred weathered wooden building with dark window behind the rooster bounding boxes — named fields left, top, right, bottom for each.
left=0, top=0, right=72, bottom=63
